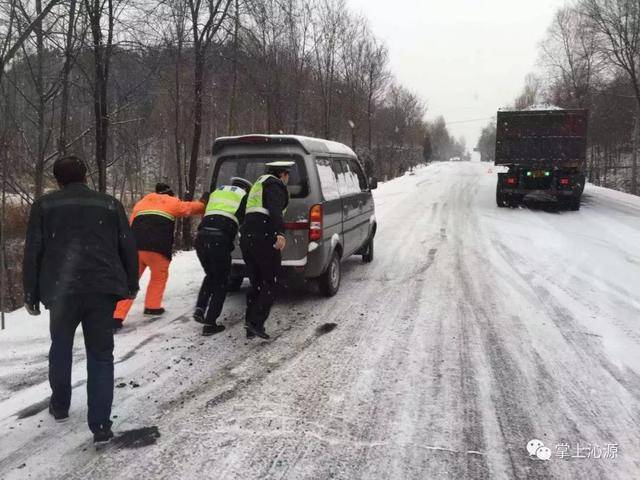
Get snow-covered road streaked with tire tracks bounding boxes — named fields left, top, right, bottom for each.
left=0, top=163, right=640, bottom=480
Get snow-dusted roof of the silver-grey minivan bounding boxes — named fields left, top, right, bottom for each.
left=211, top=134, right=356, bottom=157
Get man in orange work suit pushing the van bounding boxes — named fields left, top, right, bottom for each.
left=113, top=183, right=205, bottom=331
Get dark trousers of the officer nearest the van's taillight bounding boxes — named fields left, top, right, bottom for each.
left=240, top=233, right=281, bottom=328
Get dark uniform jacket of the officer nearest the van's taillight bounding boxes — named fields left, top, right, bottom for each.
left=240, top=177, right=289, bottom=240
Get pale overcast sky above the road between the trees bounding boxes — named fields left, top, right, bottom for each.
left=347, top=0, right=565, bottom=150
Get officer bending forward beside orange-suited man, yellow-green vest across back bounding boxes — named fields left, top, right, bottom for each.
left=193, top=177, right=251, bottom=336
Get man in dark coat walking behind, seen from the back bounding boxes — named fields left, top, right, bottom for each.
left=23, top=157, right=138, bottom=443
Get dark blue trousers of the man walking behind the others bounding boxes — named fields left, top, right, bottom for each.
left=49, top=294, right=117, bottom=431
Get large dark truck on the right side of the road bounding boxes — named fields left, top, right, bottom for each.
left=495, top=109, right=588, bottom=210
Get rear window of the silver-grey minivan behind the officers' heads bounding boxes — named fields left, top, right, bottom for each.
left=211, top=154, right=309, bottom=198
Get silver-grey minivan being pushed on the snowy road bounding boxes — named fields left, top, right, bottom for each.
left=210, top=135, right=377, bottom=296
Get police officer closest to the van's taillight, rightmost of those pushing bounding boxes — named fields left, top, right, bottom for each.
left=240, top=161, right=295, bottom=339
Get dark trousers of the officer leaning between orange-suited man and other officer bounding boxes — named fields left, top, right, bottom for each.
left=196, top=233, right=233, bottom=325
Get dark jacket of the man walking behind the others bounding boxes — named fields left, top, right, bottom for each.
left=23, top=183, right=138, bottom=307
